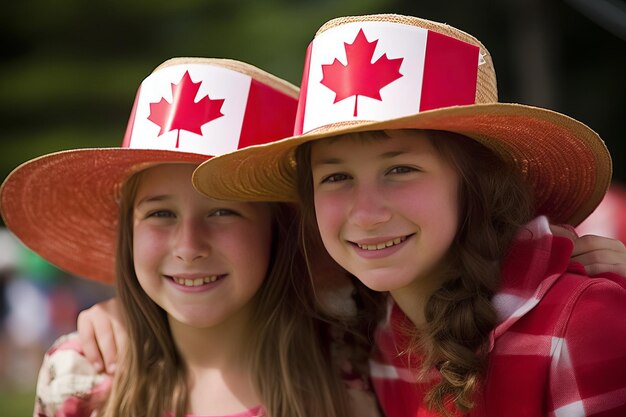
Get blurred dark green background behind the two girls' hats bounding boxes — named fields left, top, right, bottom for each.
left=0, top=0, right=626, bottom=417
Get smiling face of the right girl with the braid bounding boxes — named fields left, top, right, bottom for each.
left=311, top=131, right=459, bottom=294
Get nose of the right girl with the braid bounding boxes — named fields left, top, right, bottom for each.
left=349, top=184, right=391, bottom=230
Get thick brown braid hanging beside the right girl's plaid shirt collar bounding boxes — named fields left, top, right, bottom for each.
left=419, top=232, right=498, bottom=412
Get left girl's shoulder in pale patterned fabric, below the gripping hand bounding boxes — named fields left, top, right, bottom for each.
left=35, top=333, right=111, bottom=417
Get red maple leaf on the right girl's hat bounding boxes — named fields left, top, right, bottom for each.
left=321, top=29, right=404, bottom=117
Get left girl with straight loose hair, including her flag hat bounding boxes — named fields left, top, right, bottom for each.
left=0, top=59, right=368, bottom=417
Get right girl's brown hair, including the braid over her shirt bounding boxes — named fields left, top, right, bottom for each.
left=296, top=131, right=533, bottom=414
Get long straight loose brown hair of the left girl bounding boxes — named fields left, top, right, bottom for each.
left=101, top=166, right=349, bottom=417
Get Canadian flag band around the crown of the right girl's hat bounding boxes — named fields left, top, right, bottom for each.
left=295, top=22, right=481, bottom=134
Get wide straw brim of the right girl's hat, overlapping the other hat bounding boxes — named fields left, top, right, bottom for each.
left=193, top=103, right=612, bottom=225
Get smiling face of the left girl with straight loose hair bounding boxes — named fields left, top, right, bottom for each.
left=133, top=164, right=271, bottom=328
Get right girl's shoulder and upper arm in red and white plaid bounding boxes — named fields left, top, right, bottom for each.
left=488, top=272, right=626, bottom=417
